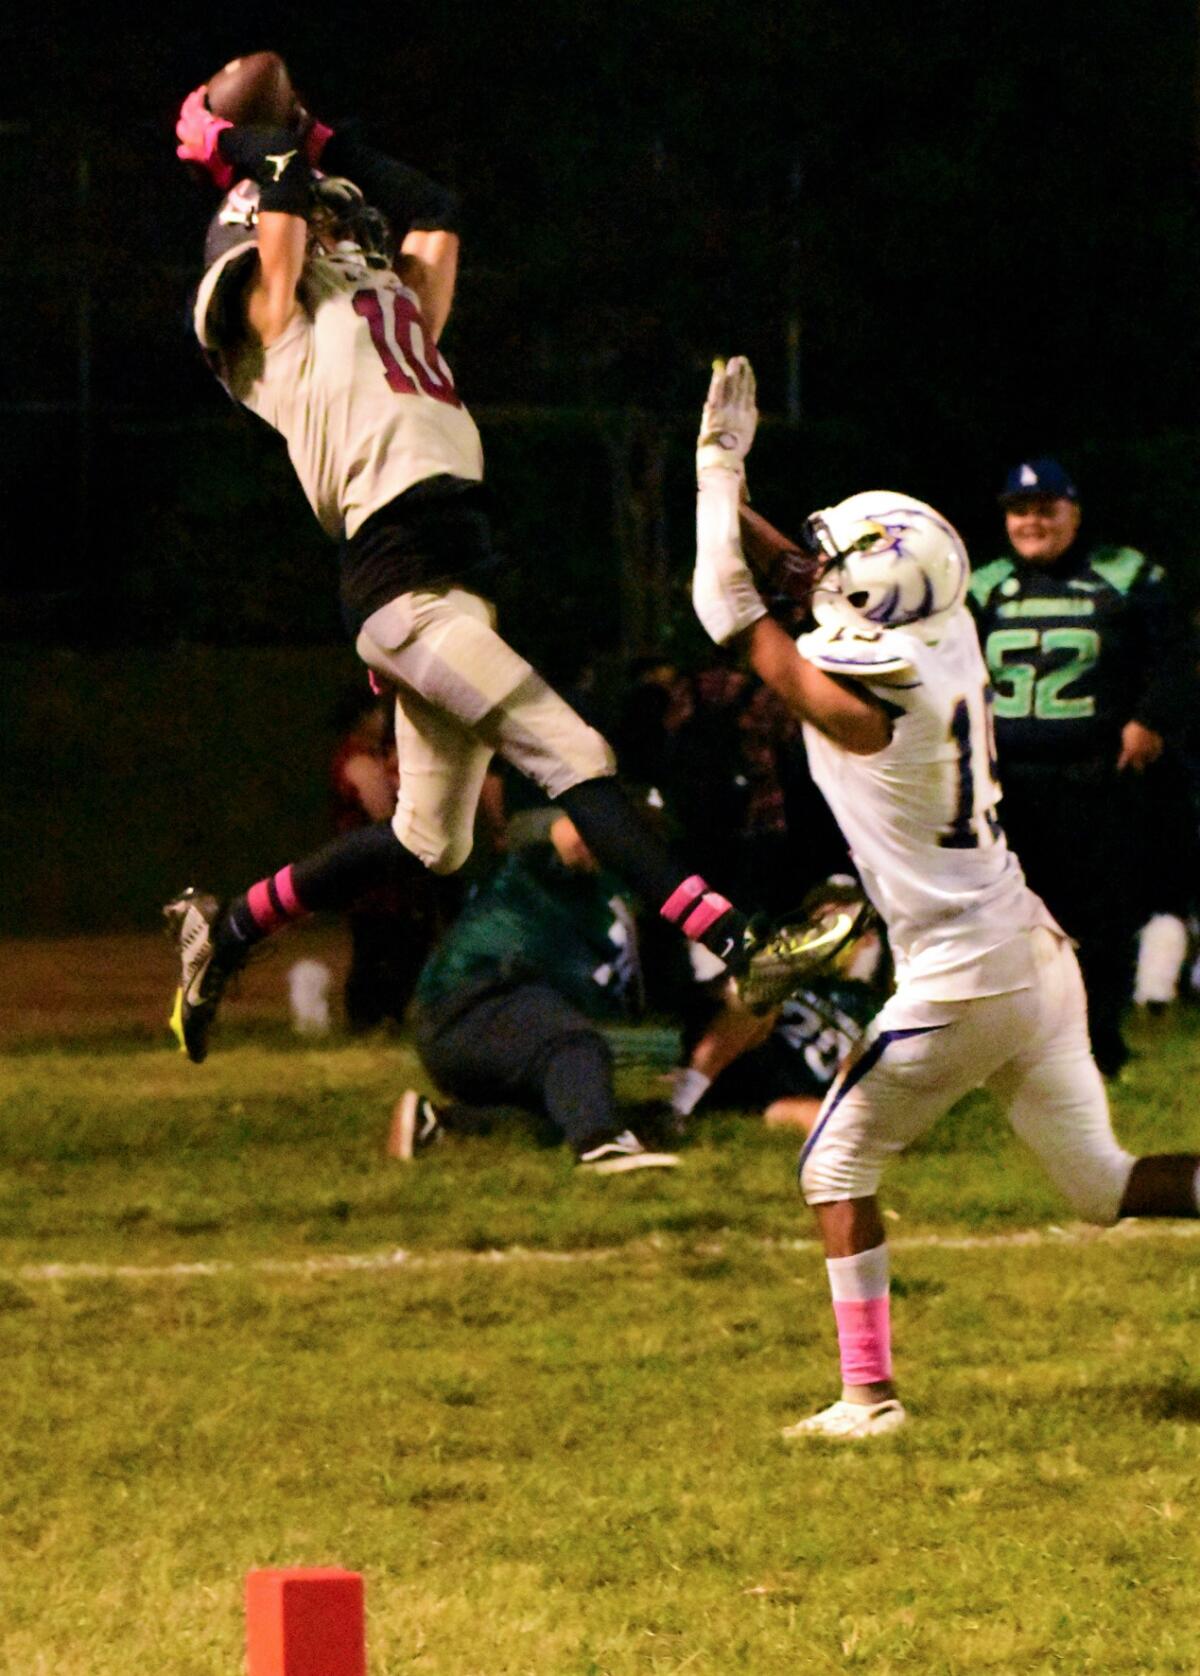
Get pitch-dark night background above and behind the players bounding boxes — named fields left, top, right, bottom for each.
left=0, top=0, right=1200, bottom=918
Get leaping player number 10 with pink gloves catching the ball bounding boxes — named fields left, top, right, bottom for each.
left=164, top=87, right=821, bottom=1086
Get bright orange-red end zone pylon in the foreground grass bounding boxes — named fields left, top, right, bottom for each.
left=246, top=1565, right=367, bottom=1676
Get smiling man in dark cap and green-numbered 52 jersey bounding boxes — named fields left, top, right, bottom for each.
left=970, top=459, right=1193, bottom=1076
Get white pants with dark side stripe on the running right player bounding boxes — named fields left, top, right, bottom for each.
left=799, top=927, right=1135, bottom=1222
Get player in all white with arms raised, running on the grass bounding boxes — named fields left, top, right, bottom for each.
left=692, top=359, right=1200, bottom=1438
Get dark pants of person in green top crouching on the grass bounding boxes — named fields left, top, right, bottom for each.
left=414, top=984, right=622, bottom=1151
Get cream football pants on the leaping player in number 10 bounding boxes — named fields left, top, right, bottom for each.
left=357, top=588, right=617, bottom=873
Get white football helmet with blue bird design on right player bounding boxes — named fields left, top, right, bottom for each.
left=804, top=489, right=970, bottom=632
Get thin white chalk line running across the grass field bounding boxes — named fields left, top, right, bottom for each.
left=9, top=1220, right=1200, bottom=1282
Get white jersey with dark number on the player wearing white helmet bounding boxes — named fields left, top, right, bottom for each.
left=796, top=608, right=1058, bottom=1001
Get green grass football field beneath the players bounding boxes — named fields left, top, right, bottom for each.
left=0, top=940, right=1200, bottom=1676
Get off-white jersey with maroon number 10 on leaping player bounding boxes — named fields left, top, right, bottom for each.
left=194, top=243, right=483, bottom=540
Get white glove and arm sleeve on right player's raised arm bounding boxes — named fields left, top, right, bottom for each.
left=692, top=355, right=766, bottom=645
